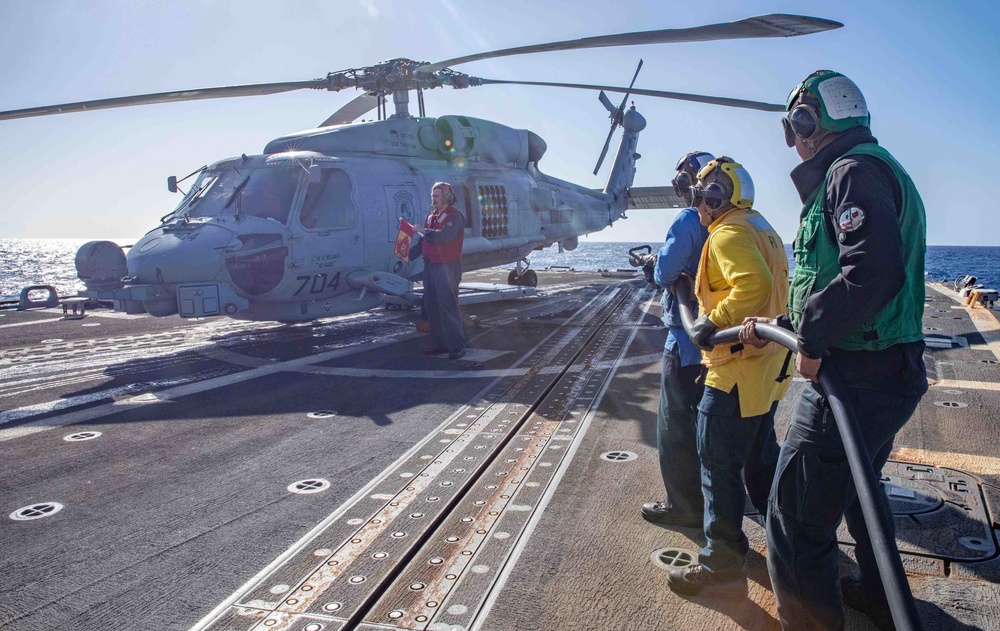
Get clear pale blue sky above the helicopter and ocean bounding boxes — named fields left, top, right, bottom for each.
left=0, top=0, right=1000, bottom=245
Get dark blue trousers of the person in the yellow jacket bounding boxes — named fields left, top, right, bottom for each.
left=698, top=386, right=778, bottom=573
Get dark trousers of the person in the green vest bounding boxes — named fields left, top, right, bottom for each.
left=767, top=383, right=920, bottom=631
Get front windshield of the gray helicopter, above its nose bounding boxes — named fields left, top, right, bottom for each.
left=182, top=165, right=299, bottom=223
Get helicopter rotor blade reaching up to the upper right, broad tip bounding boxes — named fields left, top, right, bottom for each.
left=416, top=13, right=843, bottom=73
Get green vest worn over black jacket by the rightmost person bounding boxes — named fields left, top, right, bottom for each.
left=788, top=143, right=927, bottom=351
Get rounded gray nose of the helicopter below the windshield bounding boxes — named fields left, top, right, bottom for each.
left=128, top=225, right=232, bottom=284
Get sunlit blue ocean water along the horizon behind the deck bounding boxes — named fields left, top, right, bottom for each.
left=0, top=239, right=1000, bottom=296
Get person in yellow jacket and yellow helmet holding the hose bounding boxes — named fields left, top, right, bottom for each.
left=668, top=157, right=791, bottom=599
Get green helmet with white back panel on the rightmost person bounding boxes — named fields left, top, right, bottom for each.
left=785, top=70, right=871, bottom=132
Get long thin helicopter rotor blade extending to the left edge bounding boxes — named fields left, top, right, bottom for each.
left=0, top=79, right=328, bottom=120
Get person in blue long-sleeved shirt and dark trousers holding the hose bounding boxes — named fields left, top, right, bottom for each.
left=642, top=151, right=715, bottom=528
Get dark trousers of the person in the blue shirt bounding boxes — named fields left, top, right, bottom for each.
left=656, top=345, right=704, bottom=515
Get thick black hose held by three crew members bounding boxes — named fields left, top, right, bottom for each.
left=673, top=274, right=921, bottom=631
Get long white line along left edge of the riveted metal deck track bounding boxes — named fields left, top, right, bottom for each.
left=190, top=284, right=635, bottom=631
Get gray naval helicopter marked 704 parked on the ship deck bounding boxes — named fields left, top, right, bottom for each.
left=0, top=14, right=843, bottom=322
